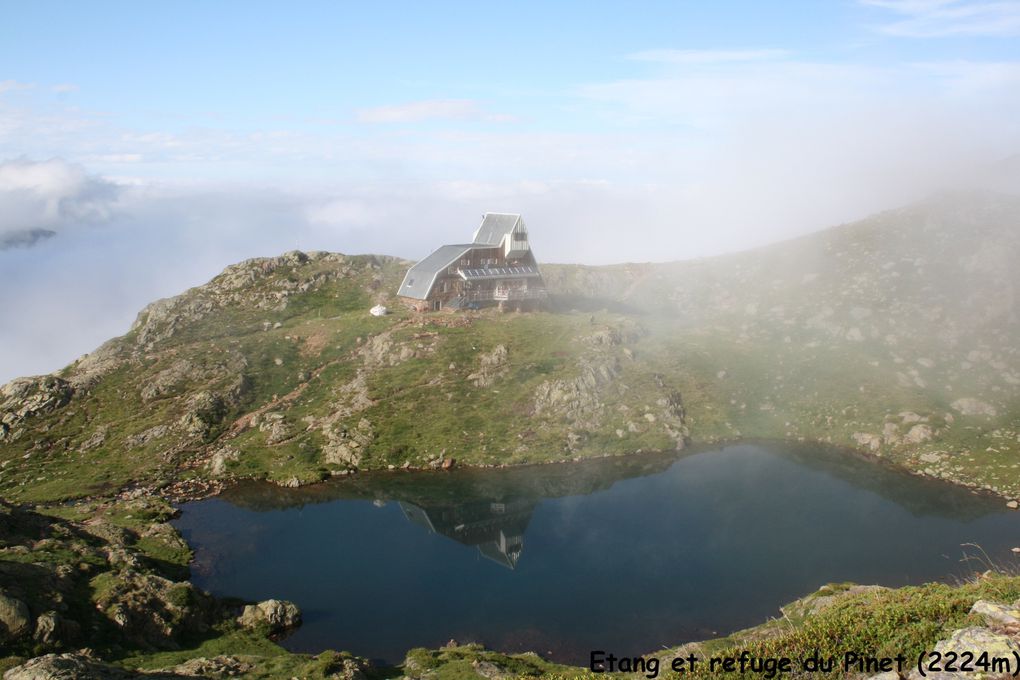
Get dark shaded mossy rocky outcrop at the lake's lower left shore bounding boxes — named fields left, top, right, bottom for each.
left=0, top=500, right=214, bottom=655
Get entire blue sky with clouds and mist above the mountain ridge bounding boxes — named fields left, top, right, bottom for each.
left=0, top=0, right=1020, bottom=380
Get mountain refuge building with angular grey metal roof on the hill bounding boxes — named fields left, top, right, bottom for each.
left=397, top=212, right=546, bottom=311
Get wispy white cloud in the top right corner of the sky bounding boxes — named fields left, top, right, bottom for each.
left=860, top=0, right=1020, bottom=38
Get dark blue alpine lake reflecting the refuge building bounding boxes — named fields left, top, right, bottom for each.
left=175, top=443, right=1020, bottom=665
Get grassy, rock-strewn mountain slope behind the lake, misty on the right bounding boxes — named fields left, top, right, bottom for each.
left=0, top=190, right=1020, bottom=501
